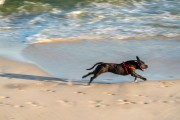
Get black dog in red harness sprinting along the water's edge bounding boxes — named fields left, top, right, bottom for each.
left=82, top=56, right=148, bottom=85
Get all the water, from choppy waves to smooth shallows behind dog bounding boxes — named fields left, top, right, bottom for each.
left=0, top=0, right=180, bottom=83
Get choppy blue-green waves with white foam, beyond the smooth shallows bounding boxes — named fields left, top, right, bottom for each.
left=0, top=0, right=180, bottom=42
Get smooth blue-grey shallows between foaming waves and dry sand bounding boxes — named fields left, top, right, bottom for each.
left=0, top=38, right=180, bottom=83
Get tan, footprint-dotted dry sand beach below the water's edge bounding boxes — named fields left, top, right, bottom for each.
left=0, top=58, right=180, bottom=120
